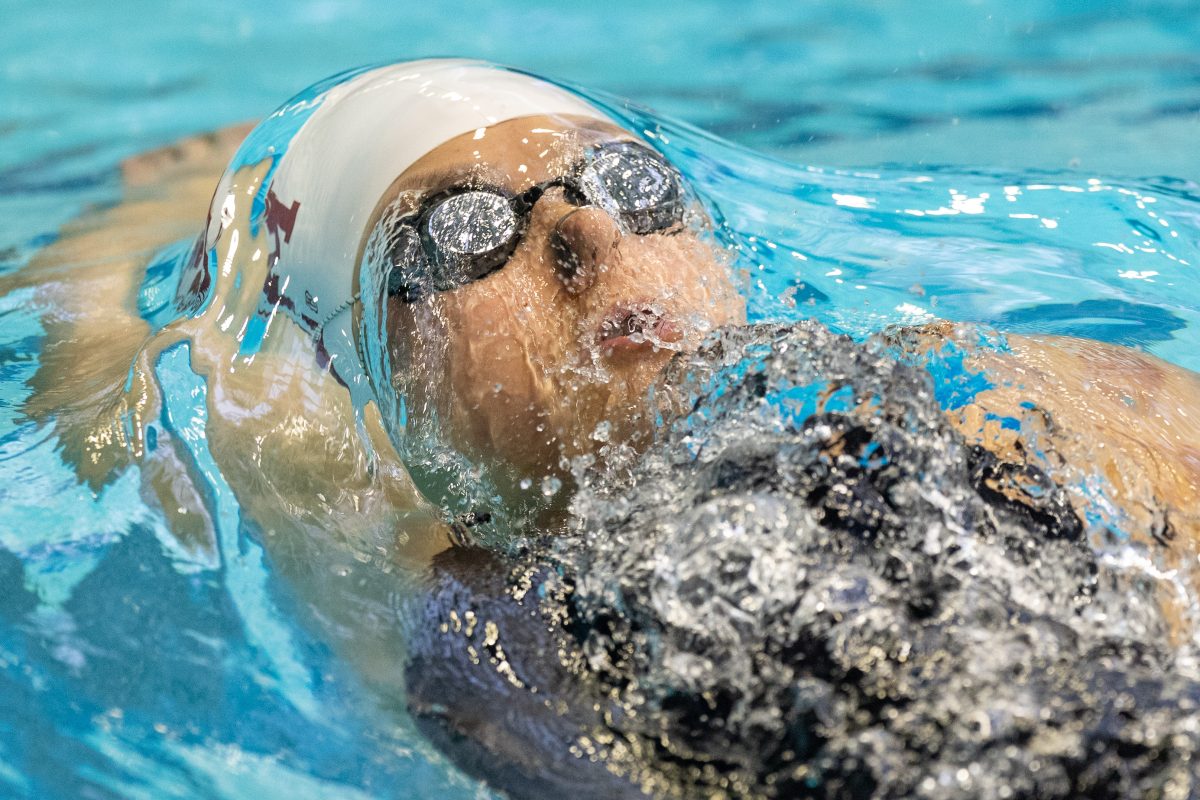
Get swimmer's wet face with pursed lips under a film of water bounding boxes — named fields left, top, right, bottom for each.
left=380, top=116, right=745, bottom=496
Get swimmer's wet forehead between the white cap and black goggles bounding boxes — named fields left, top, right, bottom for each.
left=396, top=115, right=635, bottom=192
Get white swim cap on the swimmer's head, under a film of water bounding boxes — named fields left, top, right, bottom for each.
left=256, top=59, right=608, bottom=399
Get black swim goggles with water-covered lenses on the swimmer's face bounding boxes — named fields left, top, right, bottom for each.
left=388, top=142, right=684, bottom=302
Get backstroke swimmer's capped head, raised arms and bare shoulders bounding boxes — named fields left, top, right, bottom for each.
left=4, top=60, right=1200, bottom=563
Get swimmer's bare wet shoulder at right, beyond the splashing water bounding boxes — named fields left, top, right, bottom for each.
left=886, top=321, right=1200, bottom=545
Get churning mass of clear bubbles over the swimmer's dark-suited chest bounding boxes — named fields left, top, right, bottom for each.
left=535, top=324, right=1200, bottom=798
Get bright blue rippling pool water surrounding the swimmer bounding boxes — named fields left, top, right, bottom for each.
left=0, top=0, right=1200, bottom=800
